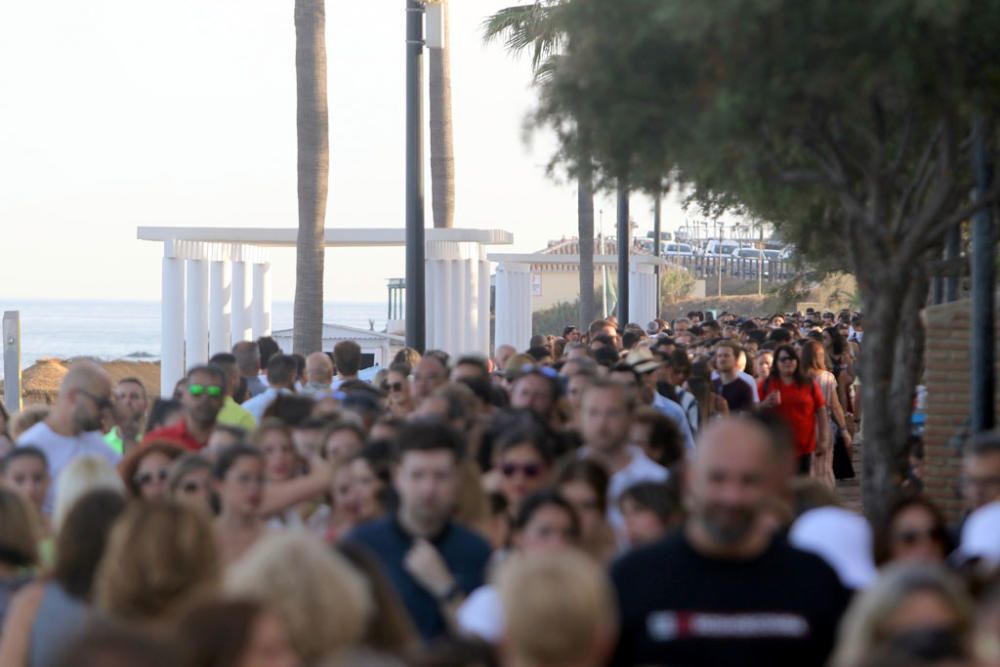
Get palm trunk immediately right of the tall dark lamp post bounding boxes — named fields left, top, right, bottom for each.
left=428, top=0, right=455, bottom=229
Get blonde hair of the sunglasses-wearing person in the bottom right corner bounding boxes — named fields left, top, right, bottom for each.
left=830, top=563, right=972, bottom=667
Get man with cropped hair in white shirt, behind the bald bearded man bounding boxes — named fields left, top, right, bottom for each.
left=579, top=378, right=670, bottom=536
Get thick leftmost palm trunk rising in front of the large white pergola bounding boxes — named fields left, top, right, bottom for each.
left=292, top=0, right=330, bottom=354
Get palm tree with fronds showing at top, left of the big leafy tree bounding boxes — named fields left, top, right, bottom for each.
left=483, top=0, right=595, bottom=330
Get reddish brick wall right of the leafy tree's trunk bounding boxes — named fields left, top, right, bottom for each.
left=924, top=295, right=1000, bottom=520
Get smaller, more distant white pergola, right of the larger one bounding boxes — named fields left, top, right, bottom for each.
left=489, top=253, right=667, bottom=350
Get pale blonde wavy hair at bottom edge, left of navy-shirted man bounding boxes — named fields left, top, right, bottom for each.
left=226, top=530, right=375, bottom=663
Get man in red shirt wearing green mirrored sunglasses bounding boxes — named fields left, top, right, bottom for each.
left=142, top=366, right=226, bottom=452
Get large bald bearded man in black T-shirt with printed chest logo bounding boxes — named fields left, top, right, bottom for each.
left=612, top=415, right=848, bottom=666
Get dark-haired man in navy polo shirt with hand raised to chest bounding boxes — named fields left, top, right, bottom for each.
left=347, top=421, right=490, bottom=640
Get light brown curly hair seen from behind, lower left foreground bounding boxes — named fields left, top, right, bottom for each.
left=95, top=501, right=222, bottom=622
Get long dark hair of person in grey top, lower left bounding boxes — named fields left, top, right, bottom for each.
left=52, top=489, right=126, bottom=602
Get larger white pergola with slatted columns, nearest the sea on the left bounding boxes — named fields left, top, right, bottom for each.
left=138, top=227, right=512, bottom=396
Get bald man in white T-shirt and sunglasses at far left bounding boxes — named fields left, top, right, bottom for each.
left=17, top=361, right=121, bottom=514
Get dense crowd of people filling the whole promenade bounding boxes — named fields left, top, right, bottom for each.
left=0, top=310, right=1000, bottom=667
